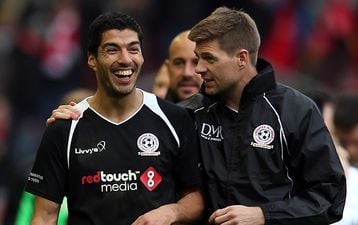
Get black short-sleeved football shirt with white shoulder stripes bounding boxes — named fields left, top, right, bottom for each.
left=26, top=91, right=201, bottom=225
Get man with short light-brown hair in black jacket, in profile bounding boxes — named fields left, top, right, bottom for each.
left=183, top=7, right=346, bottom=225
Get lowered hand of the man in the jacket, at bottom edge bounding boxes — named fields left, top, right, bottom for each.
left=209, top=205, right=265, bottom=225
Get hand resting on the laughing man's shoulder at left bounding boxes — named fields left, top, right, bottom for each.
left=46, top=102, right=80, bottom=126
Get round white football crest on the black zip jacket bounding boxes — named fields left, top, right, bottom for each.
left=251, top=124, right=275, bottom=149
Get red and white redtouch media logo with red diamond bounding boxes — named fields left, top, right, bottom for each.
left=81, top=167, right=162, bottom=192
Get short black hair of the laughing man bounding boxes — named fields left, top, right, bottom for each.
left=87, top=12, right=143, bottom=56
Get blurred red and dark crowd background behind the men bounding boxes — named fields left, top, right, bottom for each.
left=0, top=0, right=358, bottom=225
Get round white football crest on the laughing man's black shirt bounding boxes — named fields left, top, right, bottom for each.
left=137, top=133, right=160, bottom=156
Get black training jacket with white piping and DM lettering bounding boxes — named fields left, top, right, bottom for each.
left=181, top=59, right=346, bottom=225
